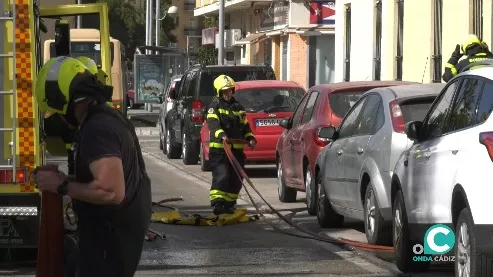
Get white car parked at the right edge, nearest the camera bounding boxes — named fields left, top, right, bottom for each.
left=391, top=60, right=493, bottom=276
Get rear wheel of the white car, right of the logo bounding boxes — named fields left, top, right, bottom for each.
left=455, top=208, right=483, bottom=277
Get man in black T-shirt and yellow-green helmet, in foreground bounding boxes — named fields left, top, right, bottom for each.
left=34, top=56, right=151, bottom=277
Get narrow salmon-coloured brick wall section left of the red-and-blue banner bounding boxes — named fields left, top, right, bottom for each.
left=288, top=34, right=308, bottom=88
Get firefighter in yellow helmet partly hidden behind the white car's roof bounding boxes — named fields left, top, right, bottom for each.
left=442, top=35, right=493, bottom=82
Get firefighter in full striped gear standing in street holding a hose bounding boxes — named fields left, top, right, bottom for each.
left=207, top=75, right=257, bottom=215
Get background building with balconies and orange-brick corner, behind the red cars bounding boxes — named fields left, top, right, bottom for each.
left=194, top=0, right=336, bottom=87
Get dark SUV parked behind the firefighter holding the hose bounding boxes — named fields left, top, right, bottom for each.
left=163, top=65, right=276, bottom=165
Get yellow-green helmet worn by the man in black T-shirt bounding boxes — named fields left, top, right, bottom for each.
left=34, top=56, right=90, bottom=114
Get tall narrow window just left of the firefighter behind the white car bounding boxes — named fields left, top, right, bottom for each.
left=431, top=0, right=443, bottom=83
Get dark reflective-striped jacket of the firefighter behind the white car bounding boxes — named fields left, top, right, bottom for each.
left=442, top=47, right=493, bottom=82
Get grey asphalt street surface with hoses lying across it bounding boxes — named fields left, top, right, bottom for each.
left=0, top=106, right=453, bottom=277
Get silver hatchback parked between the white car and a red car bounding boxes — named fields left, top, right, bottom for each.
left=315, top=84, right=444, bottom=244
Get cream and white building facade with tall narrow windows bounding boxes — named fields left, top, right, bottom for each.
left=335, top=0, right=493, bottom=83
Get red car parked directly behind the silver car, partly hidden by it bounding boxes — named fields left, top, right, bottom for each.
left=276, top=81, right=412, bottom=215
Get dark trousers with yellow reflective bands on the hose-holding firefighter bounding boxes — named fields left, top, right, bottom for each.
left=209, top=148, right=245, bottom=206
